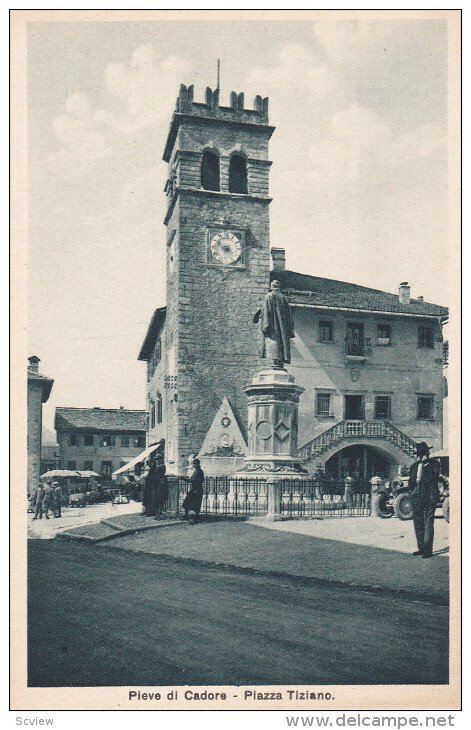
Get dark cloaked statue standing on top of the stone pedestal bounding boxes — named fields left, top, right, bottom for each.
left=254, top=279, right=294, bottom=369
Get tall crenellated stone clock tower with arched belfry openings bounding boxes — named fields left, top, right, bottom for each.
left=163, top=85, right=274, bottom=473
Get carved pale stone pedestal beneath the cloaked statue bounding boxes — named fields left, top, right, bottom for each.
left=235, top=368, right=307, bottom=479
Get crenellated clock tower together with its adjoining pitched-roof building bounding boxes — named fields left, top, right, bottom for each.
left=139, top=85, right=448, bottom=479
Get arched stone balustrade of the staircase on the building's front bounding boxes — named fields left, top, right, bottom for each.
left=298, top=421, right=416, bottom=461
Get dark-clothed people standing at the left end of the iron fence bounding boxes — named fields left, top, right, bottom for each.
left=142, top=454, right=204, bottom=521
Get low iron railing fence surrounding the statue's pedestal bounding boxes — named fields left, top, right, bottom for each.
left=167, top=476, right=371, bottom=518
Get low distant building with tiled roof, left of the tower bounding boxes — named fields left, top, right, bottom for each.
left=54, top=408, right=147, bottom=478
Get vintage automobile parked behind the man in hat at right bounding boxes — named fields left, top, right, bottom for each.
left=372, top=451, right=450, bottom=522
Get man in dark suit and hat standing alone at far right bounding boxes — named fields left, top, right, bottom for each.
left=409, top=441, right=440, bottom=558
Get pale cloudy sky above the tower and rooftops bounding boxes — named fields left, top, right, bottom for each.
left=28, top=18, right=448, bottom=428
